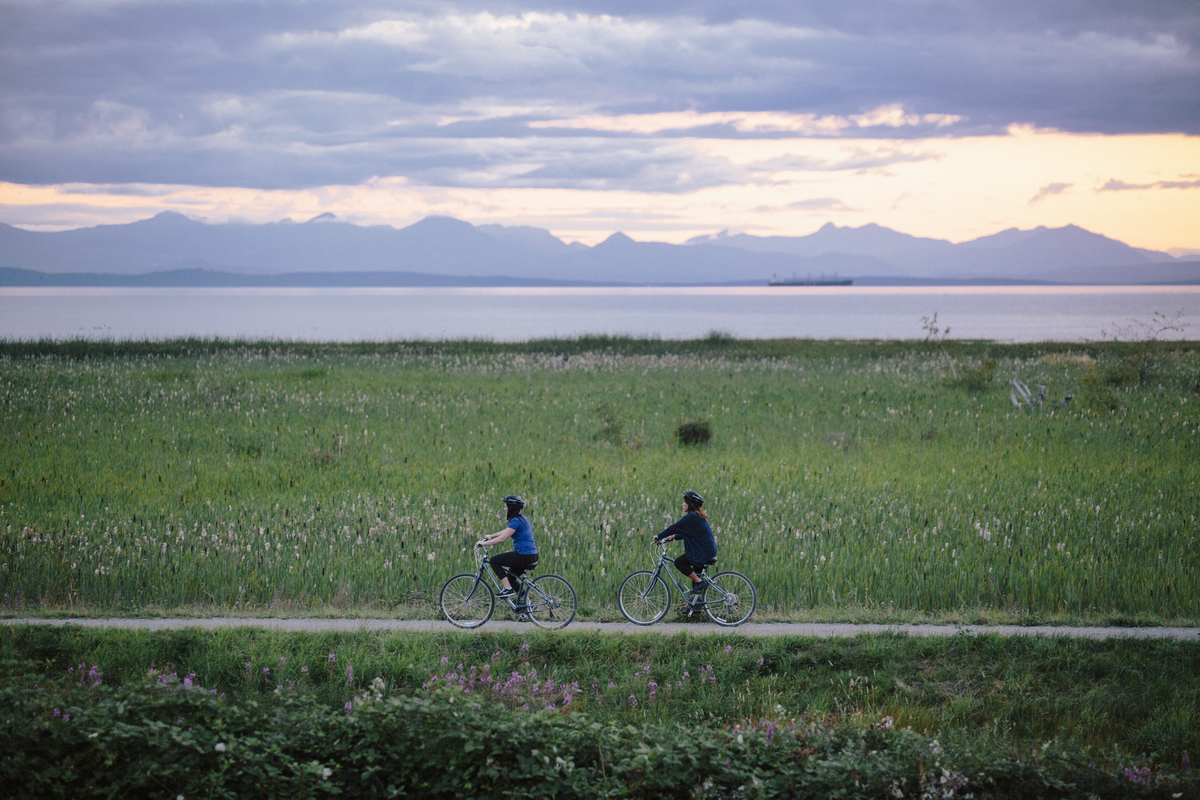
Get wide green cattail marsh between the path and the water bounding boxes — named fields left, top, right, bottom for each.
left=0, top=336, right=1200, bottom=624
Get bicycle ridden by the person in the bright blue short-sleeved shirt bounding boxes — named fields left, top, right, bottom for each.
left=438, top=545, right=578, bottom=630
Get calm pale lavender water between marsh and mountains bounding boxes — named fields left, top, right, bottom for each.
left=0, top=287, right=1200, bottom=342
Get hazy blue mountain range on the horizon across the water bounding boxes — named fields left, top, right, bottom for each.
left=0, top=211, right=1200, bottom=287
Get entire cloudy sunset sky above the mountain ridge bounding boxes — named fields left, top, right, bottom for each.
left=0, top=0, right=1200, bottom=249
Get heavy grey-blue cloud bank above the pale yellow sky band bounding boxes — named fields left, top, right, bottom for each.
left=0, top=0, right=1200, bottom=190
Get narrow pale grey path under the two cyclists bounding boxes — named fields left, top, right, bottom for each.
left=0, top=616, right=1200, bottom=642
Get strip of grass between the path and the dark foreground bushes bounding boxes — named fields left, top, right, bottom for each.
left=0, top=626, right=1200, bottom=765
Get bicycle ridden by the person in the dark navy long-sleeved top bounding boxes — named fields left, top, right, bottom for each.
left=617, top=542, right=758, bottom=627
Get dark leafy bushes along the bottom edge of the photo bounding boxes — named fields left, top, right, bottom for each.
left=0, top=662, right=1200, bottom=799
